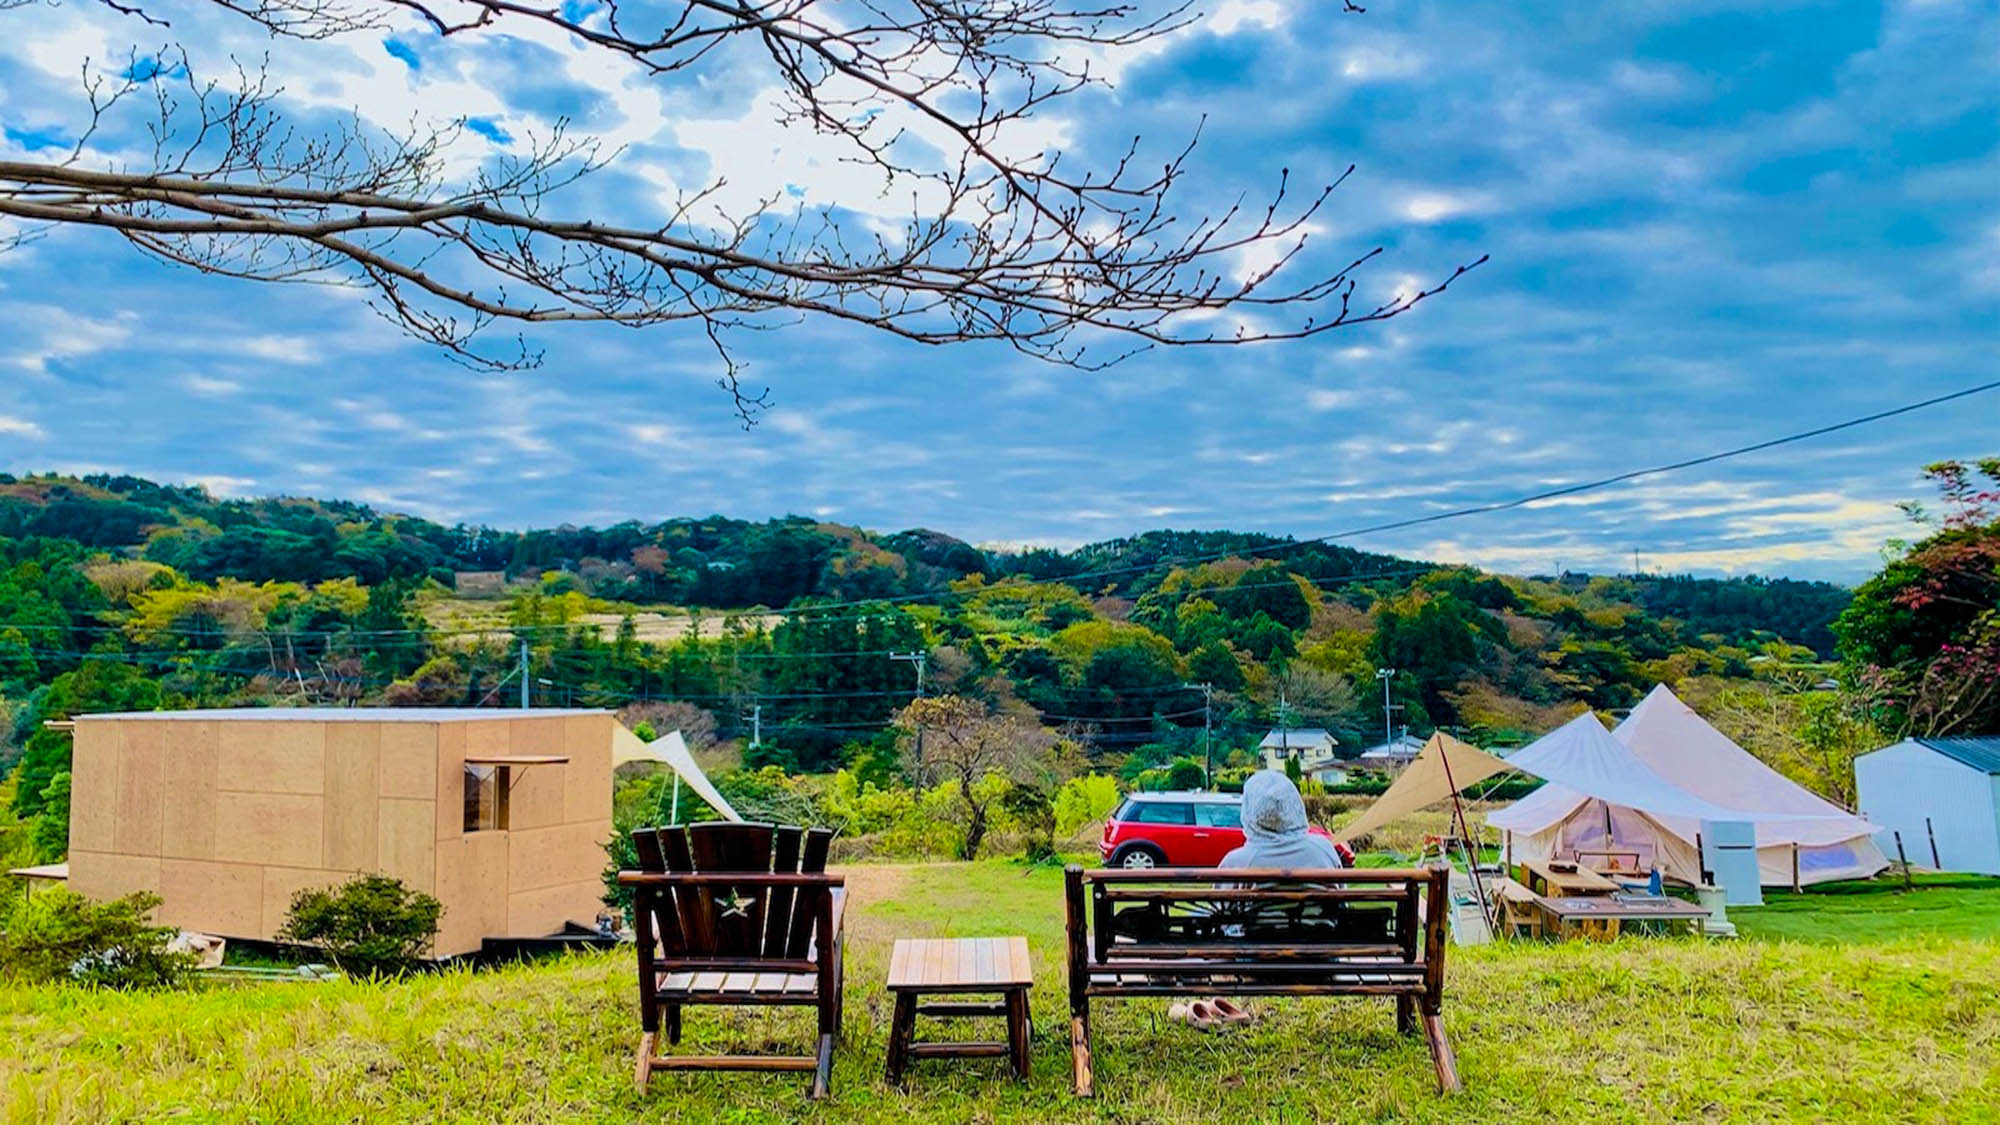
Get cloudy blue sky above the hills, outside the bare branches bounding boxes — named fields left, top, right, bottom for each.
left=0, top=0, right=2000, bottom=581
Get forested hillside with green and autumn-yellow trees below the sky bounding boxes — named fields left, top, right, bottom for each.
left=0, top=464, right=1848, bottom=831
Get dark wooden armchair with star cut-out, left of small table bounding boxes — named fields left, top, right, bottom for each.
left=618, top=821, right=846, bottom=1097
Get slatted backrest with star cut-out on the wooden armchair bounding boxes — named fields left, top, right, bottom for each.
left=632, top=821, right=838, bottom=961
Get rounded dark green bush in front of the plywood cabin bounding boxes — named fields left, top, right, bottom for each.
left=278, top=875, right=444, bottom=977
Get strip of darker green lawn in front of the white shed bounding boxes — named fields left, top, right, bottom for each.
left=1730, top=875, right=2000, bottom=943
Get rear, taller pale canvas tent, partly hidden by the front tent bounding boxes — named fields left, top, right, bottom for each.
left=1612, top=685, right=1888, bottom=887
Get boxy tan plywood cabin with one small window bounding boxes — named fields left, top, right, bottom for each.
left=70, top=709, right=616, bottom=957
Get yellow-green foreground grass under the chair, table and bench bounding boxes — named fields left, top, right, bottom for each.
left=0, top=863, right=2000, bottom=1123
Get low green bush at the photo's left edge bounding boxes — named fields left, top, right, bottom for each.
left=0, top=887, right=198, bottom=989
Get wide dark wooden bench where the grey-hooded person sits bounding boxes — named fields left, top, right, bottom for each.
left=1062, top=865, right=1460, bottom=1097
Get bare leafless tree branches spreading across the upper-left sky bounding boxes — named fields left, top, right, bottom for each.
left=0, top=0, right=1484, bottom=414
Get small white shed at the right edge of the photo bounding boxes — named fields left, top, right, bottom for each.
left=1854, top=735, right=2000, bottom=875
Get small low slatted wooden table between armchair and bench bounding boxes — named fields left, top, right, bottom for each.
left=888, top=937, right=1034, bottom=1085
